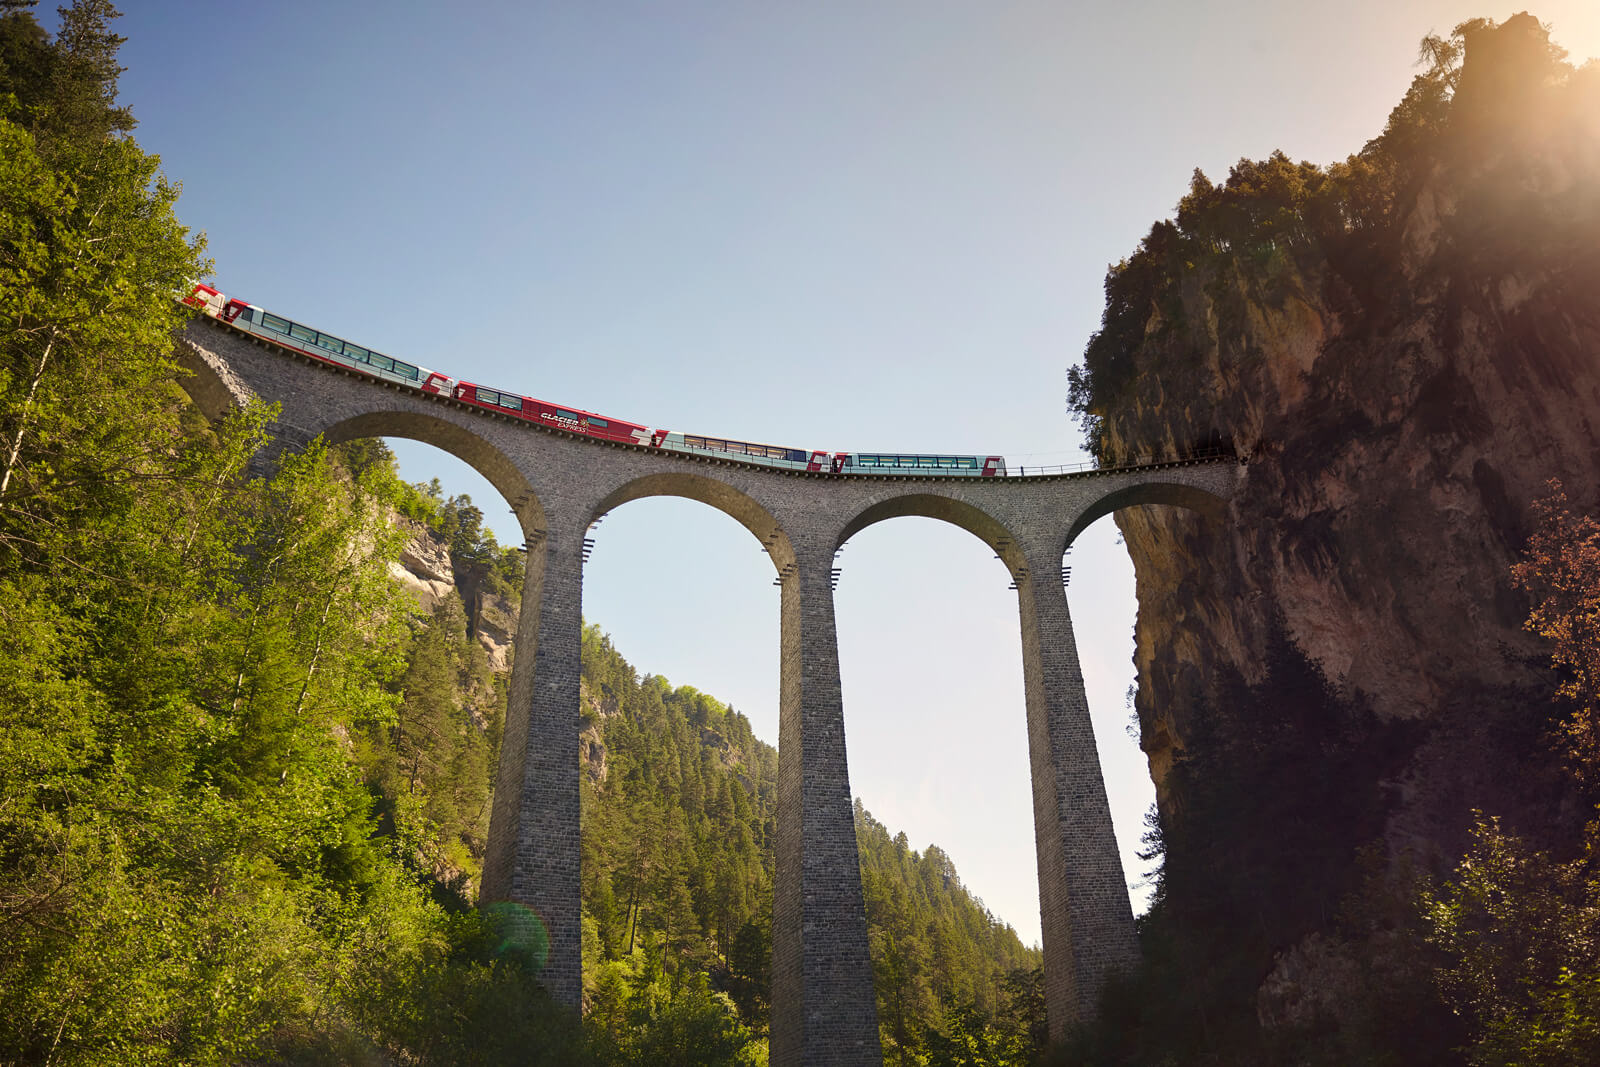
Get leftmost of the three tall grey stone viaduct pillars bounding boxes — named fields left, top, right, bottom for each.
left=478, top=515, right=584, bottom=1011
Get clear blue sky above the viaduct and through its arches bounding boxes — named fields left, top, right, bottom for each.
left=106, top=0, right=1600, bottom=939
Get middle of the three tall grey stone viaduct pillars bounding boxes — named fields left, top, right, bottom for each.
left=771, top=545, right=883, bottom=1067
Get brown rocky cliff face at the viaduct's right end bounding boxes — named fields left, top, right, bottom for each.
left=1094, top=16, right=1600, bottom=883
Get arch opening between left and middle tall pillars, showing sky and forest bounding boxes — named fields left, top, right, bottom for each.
left=581, top=489, right=792, bottom=1024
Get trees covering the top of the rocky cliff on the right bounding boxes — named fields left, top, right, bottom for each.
left=1067, top=16, right=1597, bottom=462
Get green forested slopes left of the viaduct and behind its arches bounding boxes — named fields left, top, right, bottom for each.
left=0, top=0, right=1040, bottom=1065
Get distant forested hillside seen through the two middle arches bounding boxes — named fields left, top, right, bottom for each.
left=569, top=627, right=1043, bottom=1064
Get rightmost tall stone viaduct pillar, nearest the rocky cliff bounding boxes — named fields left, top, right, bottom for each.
left=1018, top=552, right=1139, bottom=1040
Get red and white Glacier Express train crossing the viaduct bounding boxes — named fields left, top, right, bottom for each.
left=182, top=282, right=1005, bottom=478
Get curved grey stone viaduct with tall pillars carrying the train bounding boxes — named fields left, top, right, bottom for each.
left=181, top=315, right=1238, bottom=1067
